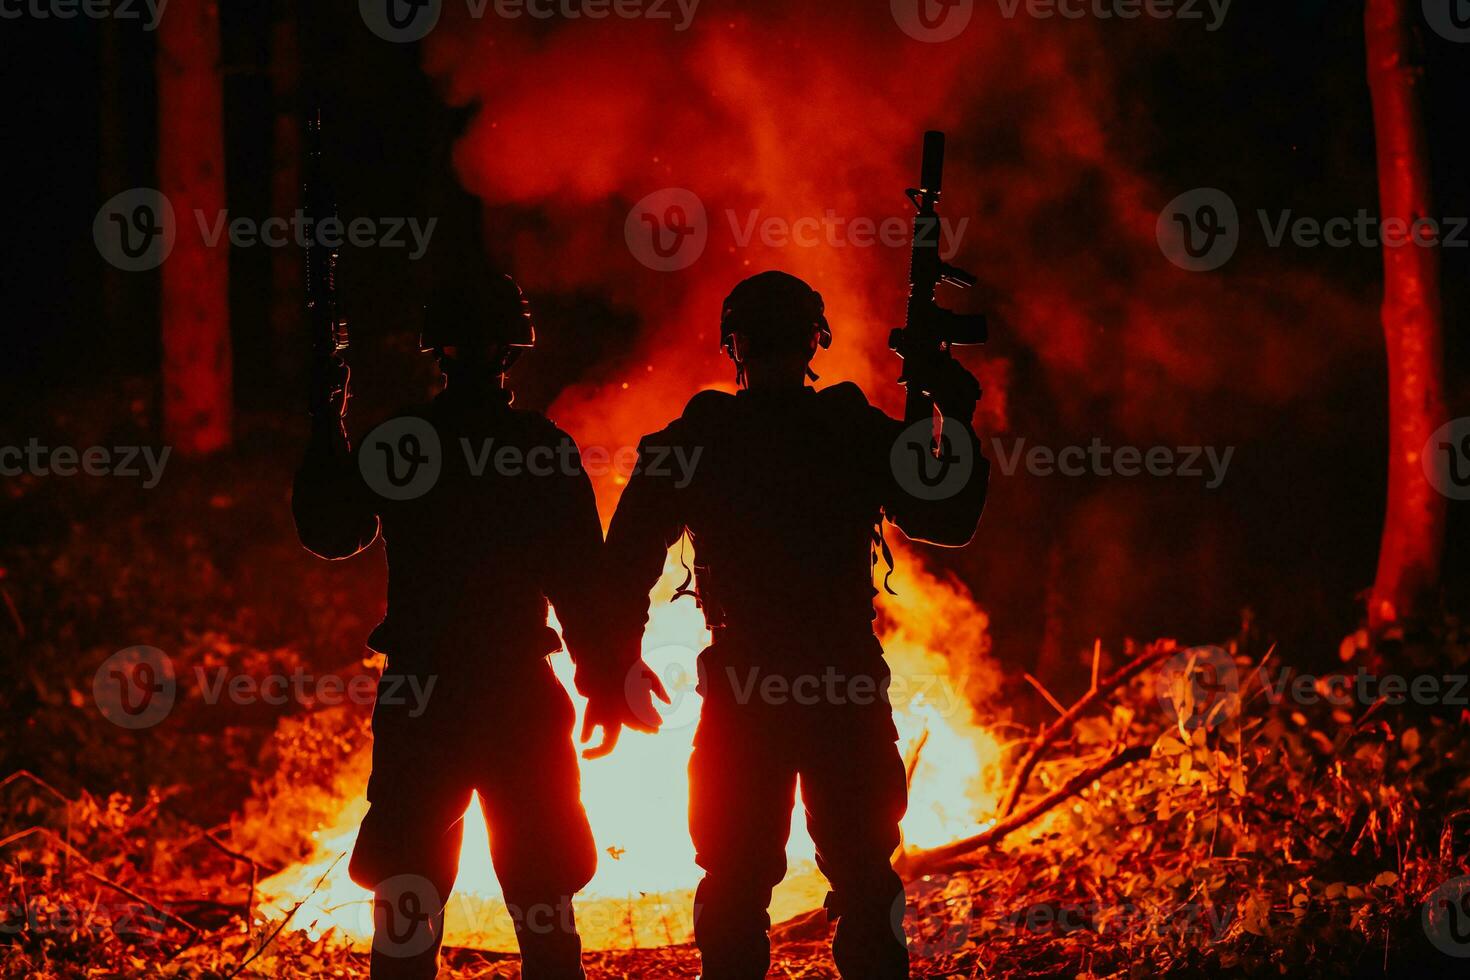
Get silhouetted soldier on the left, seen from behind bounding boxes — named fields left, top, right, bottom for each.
left=293, top=278, right=662, bottom=980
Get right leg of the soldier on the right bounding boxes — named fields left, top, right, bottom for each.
left=801, top=723, right=908, bottom=980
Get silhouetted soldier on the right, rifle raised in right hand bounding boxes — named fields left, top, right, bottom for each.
left=607, top=272, right=989, bottom=980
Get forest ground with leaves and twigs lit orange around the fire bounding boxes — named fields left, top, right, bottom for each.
left=0, top=405, right=1470, bottom=977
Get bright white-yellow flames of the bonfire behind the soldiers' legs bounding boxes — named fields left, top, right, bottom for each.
left=260, top=537, right=1001, bottom=949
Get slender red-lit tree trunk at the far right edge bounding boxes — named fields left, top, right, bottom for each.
left=1364, top=0, right=1446, bottom=627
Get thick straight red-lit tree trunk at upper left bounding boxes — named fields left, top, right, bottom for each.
left=157, top=0, right=232, bottom=455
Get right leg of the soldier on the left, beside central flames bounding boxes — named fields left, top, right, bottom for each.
left=479, top=667, right=597, bottom=980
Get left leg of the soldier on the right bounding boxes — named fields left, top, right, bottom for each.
left=689, top=720, right=797, bottom=980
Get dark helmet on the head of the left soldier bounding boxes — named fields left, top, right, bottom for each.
left=419, top=276, right=537, bottom=359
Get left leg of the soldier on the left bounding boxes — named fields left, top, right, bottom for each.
left=348, top=669, right=470, bottom=980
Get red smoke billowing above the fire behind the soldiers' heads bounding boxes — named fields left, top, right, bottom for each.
left=428, top=4, right=1364, bottom=452
